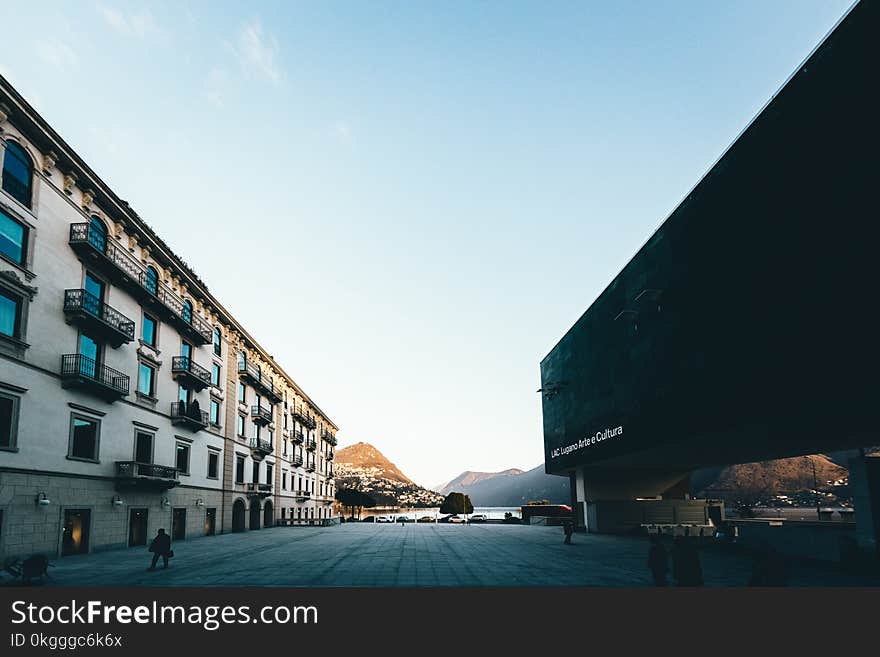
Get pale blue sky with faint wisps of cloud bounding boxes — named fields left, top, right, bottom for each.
left=0, top=0, right=851, bottom=485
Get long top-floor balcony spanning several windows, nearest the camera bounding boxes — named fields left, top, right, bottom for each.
left=68, top=222, right=212, bottom=345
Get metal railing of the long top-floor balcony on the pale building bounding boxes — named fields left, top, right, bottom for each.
left=69, top=222, right=212, bottom=344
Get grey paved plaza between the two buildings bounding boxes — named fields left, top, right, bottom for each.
left=15, top=523, right=880, bottom=587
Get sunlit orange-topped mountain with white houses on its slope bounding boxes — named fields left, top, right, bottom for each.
left=334, top=443, right=443, bottom=507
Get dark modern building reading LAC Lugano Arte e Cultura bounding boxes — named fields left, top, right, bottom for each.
left=541, top=2, right=880, bottom=549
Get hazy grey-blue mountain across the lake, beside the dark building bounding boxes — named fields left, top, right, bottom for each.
left=443, top=465, right=571, bottom=506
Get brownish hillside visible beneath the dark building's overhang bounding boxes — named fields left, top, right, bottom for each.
left=691, top=454, right=848, bottom=500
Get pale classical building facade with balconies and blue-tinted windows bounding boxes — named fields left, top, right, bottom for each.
left=0, top=77, right=337, bottom=558
